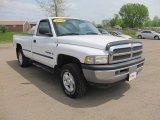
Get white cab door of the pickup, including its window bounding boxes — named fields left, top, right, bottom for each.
left=32, top=20, right=57, bottom=68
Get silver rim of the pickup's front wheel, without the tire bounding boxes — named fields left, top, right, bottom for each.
left=63, top=72, right=75, bottom=93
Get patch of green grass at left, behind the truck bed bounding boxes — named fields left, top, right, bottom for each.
left=0, top=32, right=26, bottom=43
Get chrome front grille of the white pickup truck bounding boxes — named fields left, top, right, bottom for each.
left=109, top=42, right=143, bottom=64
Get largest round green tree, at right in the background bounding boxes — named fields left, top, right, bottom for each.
left=119, top=3, right=149, bottom=28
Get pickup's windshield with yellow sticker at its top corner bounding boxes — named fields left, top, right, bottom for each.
left=52, top=19, right=100, bottom=36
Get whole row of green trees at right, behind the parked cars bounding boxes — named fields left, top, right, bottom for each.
left=102, top=3, right=160, bottom=28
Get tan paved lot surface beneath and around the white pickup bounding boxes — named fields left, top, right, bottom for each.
left=0, top=40, right=160, bottom=120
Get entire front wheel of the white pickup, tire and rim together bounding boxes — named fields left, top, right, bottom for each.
left=61, top=63, right=87, bottom=98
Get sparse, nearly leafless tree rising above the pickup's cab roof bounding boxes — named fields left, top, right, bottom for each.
left=36, top=0, right=65, bottom=17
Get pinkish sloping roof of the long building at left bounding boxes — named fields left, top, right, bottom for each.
left=0, top=21, right=27, bottom=25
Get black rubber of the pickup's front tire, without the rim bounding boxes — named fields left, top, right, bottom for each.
left=61, top=63, right=87, bottom=98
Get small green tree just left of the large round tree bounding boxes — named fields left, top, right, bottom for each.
left=110, top=14, right=123, bottom=27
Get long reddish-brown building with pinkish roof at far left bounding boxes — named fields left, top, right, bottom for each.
left=0, top=21, right=31, bottom=32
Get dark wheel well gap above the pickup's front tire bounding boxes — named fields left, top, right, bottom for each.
left=57, top=54, right=81, bottom=68
